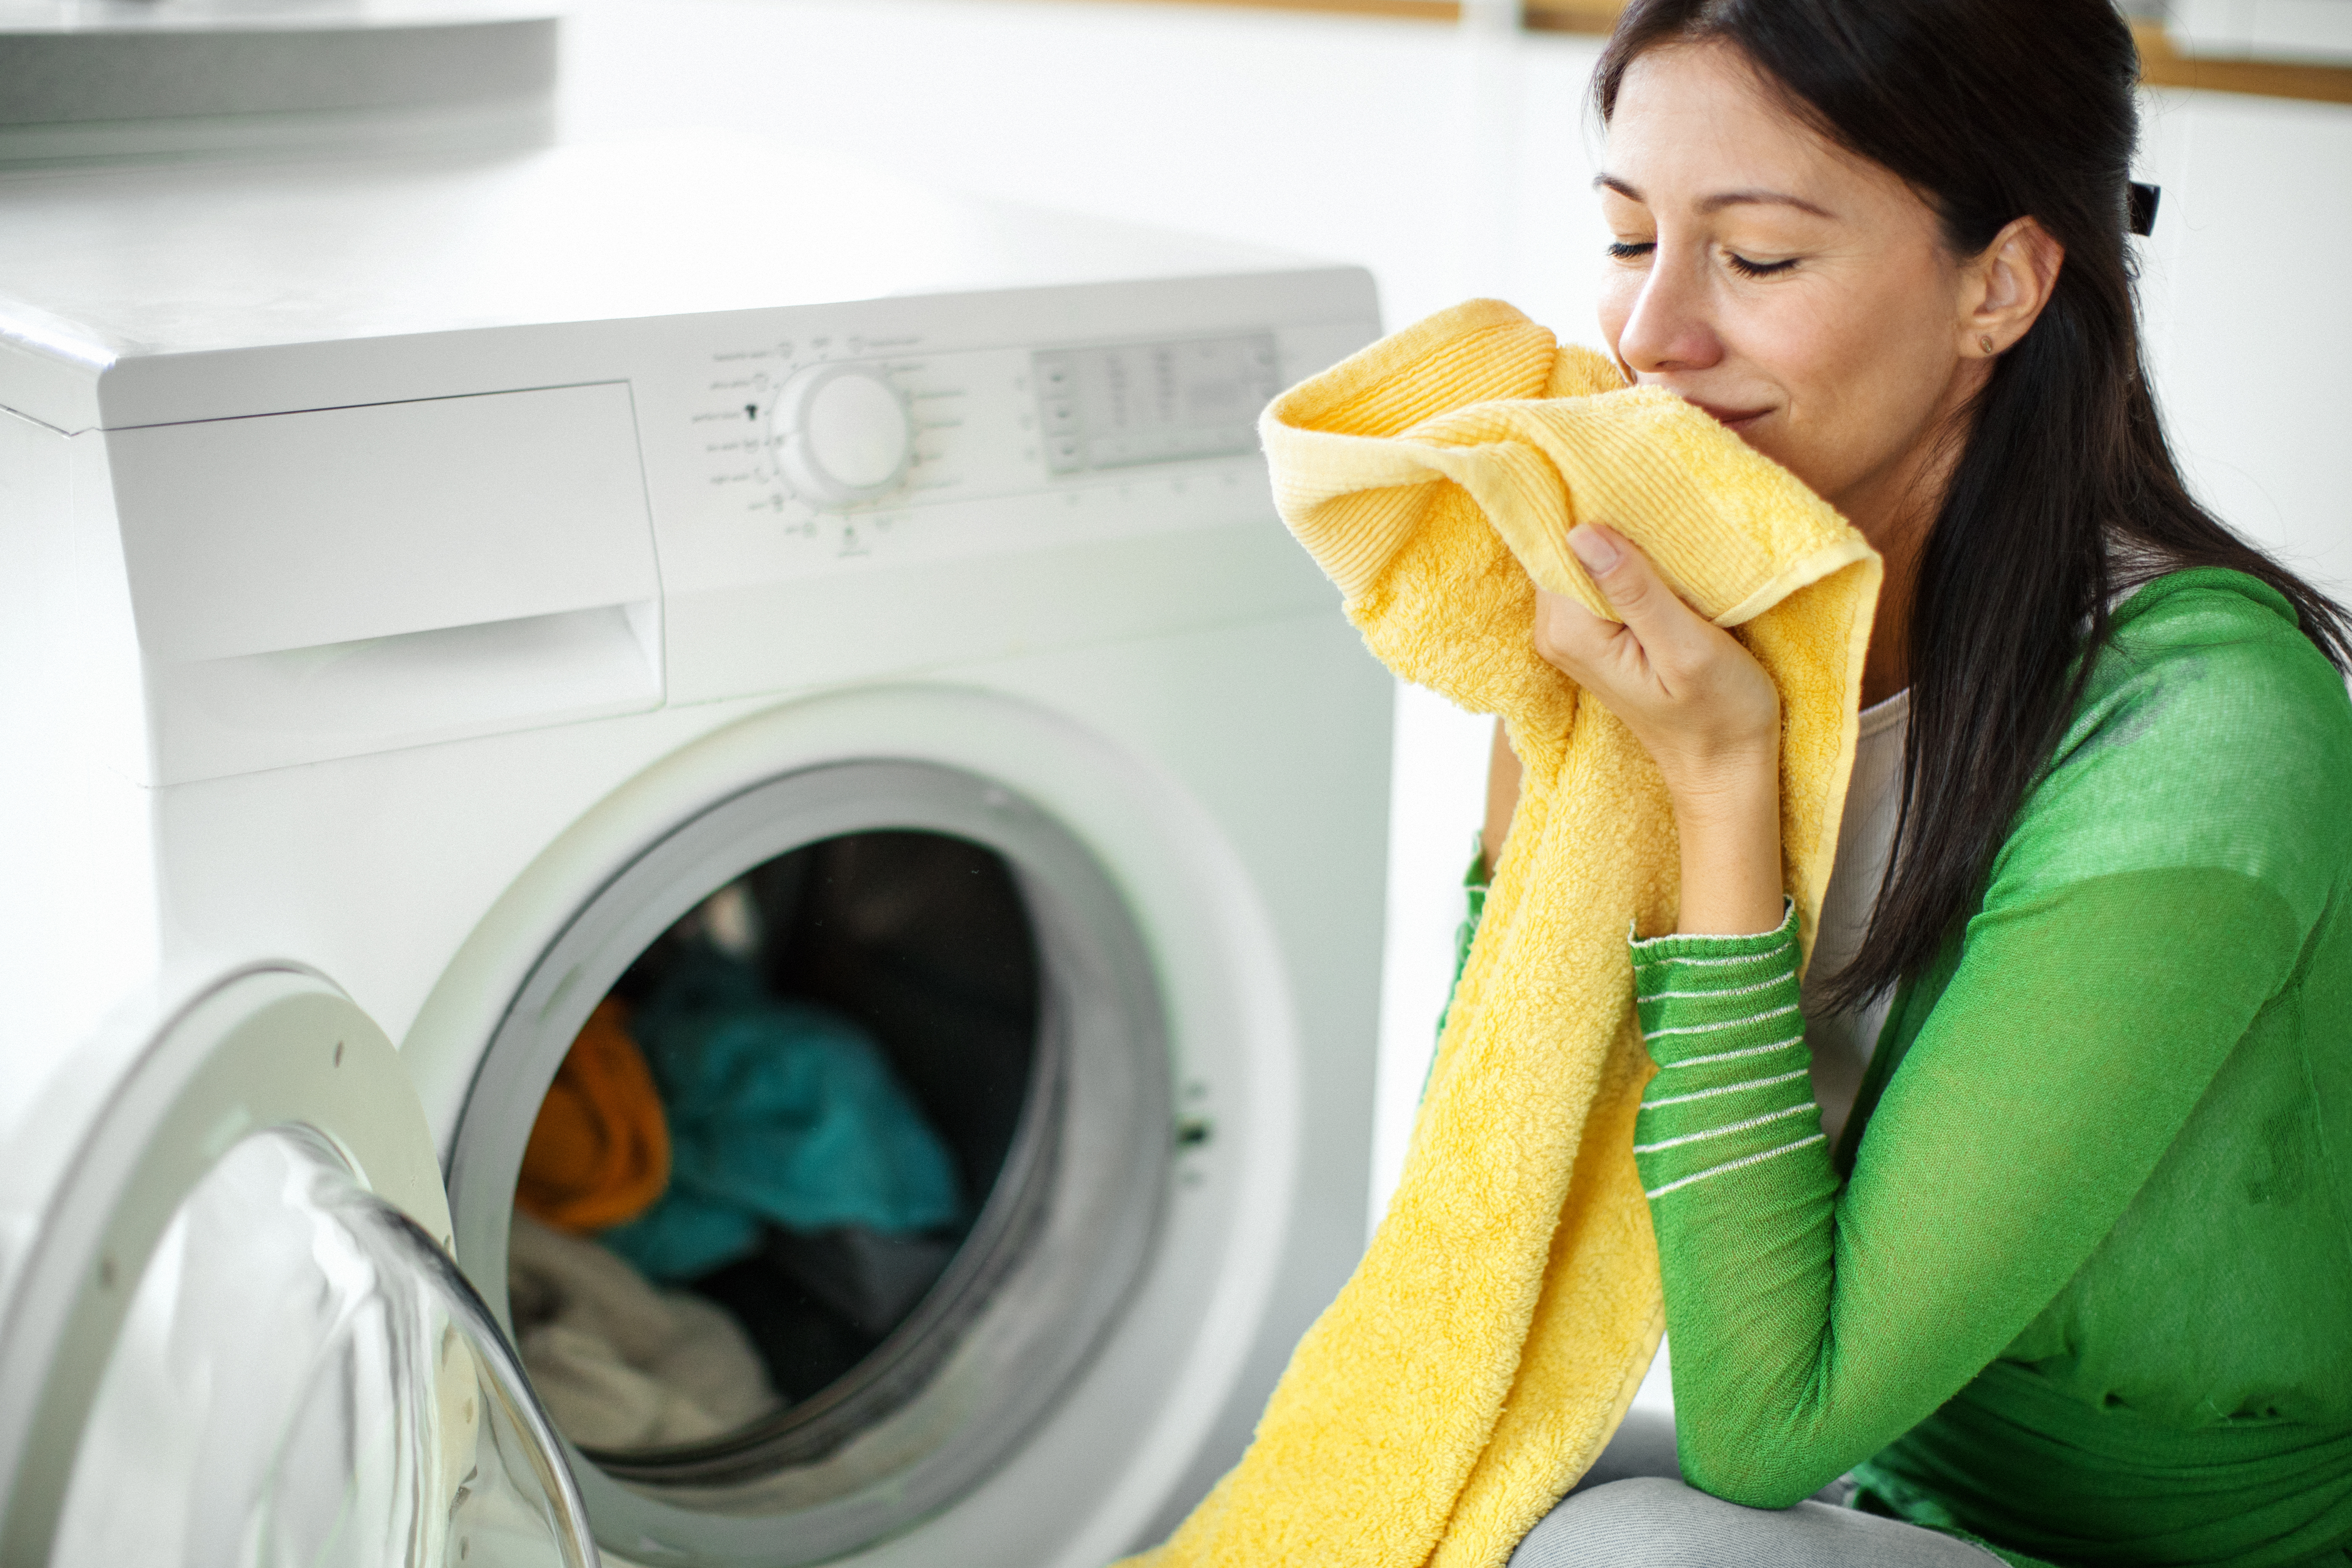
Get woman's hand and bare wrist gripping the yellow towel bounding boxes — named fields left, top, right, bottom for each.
left=1536, top=524, right=1780, bottom=935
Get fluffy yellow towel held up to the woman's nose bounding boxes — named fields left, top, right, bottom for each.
left=1136, top=301, right=1879, bottom=1568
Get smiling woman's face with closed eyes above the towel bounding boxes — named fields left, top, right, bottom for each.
left=1595, top=42, right=1990, bottom=536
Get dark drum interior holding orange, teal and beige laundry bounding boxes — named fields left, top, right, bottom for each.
left=508, top=830, right=1051, bottom=1484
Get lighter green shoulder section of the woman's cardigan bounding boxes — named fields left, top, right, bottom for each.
left=2002, top=569, right=2352, bottom=912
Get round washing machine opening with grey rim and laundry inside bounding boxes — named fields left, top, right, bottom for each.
left=449, top=762, right=1171, bottom=1568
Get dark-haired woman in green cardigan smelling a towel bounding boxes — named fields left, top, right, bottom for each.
left=1498, top=0, right=2352, bottom=1568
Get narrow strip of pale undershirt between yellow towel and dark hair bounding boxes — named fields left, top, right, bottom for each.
left=1802, top=689, right=1910, bottom=1147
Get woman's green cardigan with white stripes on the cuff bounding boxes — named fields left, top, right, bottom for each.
left=1458, top=571, right=2352, bottom=1568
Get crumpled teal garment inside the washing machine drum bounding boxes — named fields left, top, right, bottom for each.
left=597, top=950, right=962, bottom=1279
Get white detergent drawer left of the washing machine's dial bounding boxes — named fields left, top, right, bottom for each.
left=106, top=383, right=663, bottom=783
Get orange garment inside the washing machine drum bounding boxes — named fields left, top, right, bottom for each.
left=515, top=997, right=670, bottom=1232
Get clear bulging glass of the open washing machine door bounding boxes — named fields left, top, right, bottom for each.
left=50, top=1128, right=597, bottom=1568
